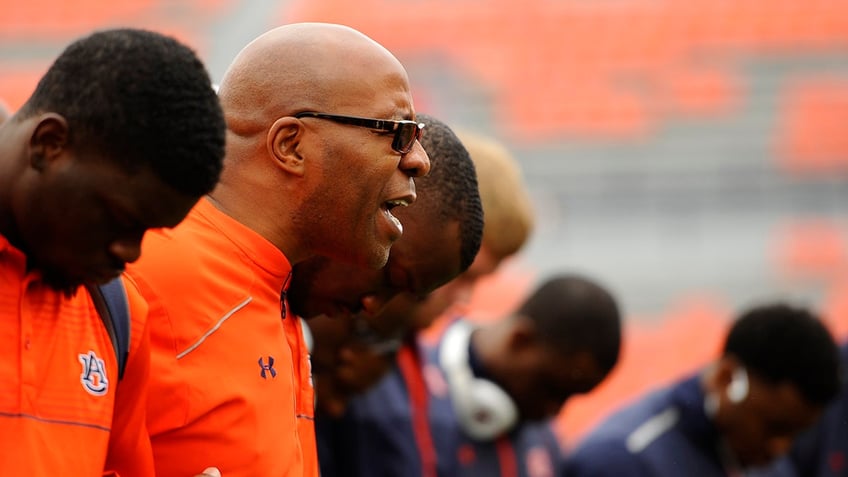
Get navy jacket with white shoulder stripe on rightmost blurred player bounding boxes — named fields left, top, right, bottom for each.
left=563, top=375, right=728, bottom=477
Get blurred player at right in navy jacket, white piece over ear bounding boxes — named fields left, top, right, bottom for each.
left=562, top=303, right=840, bottom=477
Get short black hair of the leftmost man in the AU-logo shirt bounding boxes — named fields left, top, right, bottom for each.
left=19, top=29, right=226, bottom=197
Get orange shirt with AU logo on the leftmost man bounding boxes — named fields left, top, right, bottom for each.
left=0, top=235, right=155, bottom=477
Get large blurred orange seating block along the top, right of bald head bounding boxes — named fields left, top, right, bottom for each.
left=281, top=0, right=848, bottom=141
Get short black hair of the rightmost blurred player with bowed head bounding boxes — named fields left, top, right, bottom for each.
left=724, top=303, right=840, bottom=405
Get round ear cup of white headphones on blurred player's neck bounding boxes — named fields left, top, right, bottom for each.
left=455, top=379, right=518, bottom=440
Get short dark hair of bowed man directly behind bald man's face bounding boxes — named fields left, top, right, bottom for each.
left=415, top=114, right=484, bottom=272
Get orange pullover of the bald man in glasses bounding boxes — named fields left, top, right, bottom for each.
left=128, top=199, right=318, bottom=477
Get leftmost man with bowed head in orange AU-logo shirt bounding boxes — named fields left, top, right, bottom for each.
left=0, top=29, right=225, bottom=477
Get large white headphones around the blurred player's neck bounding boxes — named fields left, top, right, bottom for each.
left=439, top=321, right=518, bottom=441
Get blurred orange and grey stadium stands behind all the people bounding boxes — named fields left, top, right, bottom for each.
left=0, top=0, right=848, bottom=446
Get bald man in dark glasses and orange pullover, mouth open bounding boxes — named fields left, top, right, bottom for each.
left=130, top=23, right=430, bottom=477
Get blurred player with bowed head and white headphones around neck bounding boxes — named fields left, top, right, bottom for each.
left=424, top=275, right=621, bottom=477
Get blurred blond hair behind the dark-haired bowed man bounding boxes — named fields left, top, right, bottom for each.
left=457, top=130, right=534, bottom=259
